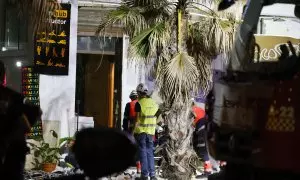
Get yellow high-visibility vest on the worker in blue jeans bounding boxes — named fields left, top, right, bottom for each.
left=134, top=98, right=158, bottom=135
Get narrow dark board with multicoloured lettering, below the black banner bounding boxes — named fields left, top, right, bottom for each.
left=22, top=67, right=43, bottom=139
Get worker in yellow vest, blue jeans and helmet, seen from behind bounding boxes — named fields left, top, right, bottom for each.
left=134, top=84, right=158, bottom=180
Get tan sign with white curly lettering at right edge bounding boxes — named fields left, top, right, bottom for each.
left=254, top=35, right=300, bottom=62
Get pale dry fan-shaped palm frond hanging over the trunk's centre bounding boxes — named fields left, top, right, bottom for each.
left=156, top=52, right=199, bottom=105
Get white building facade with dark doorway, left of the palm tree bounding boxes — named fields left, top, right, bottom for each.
left=0, top=0, right=143, bottom=136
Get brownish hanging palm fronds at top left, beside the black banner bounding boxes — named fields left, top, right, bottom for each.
left=8, top=0, right=60, bottom=34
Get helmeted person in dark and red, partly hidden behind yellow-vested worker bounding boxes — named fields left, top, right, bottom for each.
left=123, top=90, right=138, bottom=134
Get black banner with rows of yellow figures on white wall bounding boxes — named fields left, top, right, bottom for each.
left=34, top=4, right=71, bottom=75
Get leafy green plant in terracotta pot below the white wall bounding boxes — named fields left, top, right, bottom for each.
left=29, top=130, right=60, bottom=172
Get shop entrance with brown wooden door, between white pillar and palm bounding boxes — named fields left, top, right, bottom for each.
left=76, top=4, right=145, bottom=128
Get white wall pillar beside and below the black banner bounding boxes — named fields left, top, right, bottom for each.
left=39, top=0, right=78, bottom=137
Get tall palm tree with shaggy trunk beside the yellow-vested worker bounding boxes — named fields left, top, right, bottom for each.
left=97, top=0, right=242, bottom=180
